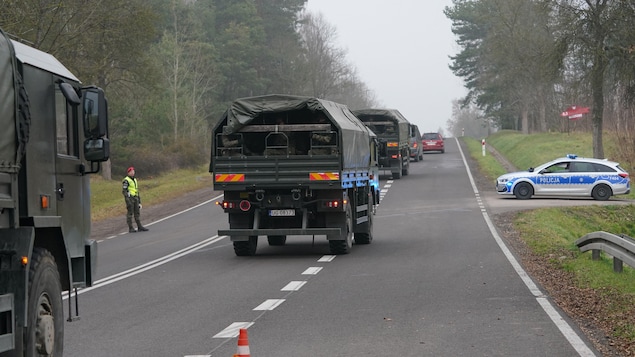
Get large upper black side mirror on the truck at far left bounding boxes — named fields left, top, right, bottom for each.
left=83, top=87, right=108, bottom=139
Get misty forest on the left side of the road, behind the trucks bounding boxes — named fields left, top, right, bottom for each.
left=0, top=0, right=376, bottom=178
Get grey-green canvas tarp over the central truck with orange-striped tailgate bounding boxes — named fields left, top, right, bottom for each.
left=214, top=94, right=370, bottom=169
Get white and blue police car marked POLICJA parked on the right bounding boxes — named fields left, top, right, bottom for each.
left=496, top=154, right=631, bottom=201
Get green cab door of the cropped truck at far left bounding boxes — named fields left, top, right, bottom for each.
left=55, top=88, right=90, bottom=257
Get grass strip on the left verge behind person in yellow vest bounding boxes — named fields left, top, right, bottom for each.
left=90, top=165, right=212, bottom=221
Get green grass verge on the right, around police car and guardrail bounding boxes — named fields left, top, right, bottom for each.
left=464, top=131, right=635, bottom=345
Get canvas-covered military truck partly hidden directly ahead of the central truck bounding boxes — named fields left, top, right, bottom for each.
left=353, top=109, right=410, bottom=179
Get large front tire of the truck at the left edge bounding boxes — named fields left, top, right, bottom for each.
left=24, top=248, right=64, bottom=357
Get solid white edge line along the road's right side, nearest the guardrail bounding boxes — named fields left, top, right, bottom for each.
left=454, top=138, right=595, bottom=357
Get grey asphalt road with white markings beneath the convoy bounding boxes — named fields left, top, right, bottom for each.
left=65, top=139, right=599, bottom=357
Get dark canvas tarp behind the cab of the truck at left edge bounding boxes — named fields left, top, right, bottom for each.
left=0, top=30, right=20, bottom=173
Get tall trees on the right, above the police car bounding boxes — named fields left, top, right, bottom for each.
left=445, top=0, right=635, bottom=158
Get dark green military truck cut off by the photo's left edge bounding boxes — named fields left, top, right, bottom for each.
left=0, top=30, right=109, bottom=356
